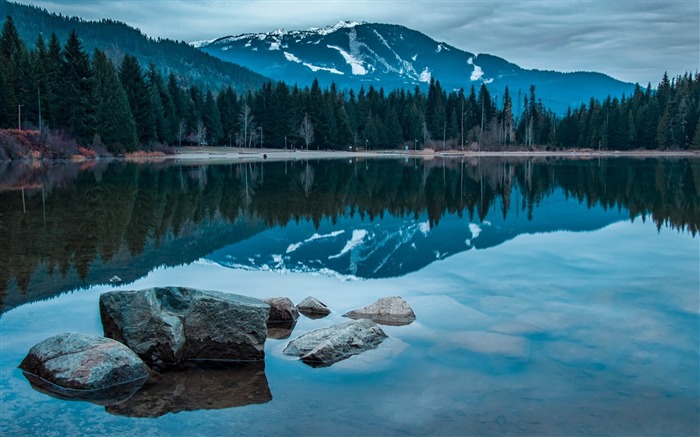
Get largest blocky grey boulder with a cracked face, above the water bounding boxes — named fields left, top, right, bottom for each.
left=100, top=287, right=270, bottom=366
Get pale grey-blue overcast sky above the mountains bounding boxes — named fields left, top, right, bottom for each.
left=12, top=0, right=700, bottom=85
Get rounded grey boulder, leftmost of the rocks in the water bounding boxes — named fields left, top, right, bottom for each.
left=19, top=332, right=149, bottom=405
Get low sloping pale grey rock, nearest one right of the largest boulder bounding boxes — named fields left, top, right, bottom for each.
left=282, top=319, right=387, bottom=367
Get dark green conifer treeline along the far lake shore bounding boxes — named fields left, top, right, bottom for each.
left=0, top=16, right=700, bottom=160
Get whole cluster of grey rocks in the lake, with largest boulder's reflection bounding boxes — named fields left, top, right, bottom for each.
left=19, top=287, right=415, bottom=408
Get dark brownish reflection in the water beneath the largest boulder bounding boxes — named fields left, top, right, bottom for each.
left=106, top=361, right=272, bottom=417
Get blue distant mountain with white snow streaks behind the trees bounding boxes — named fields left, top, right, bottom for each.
left=192, top=21, right=633, bottom=112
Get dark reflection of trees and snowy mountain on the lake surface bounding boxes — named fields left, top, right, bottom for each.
left=0, top=158, right=700, bottom=312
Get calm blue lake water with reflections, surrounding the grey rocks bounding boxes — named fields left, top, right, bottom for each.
left=0, top=158, right=700, bottom=436
